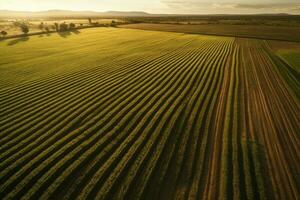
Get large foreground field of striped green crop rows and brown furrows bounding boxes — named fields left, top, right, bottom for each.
left=0, top=28, right=300, bottom=200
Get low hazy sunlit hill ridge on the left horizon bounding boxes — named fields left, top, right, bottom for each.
left=0, top=10, right=151, bottom=18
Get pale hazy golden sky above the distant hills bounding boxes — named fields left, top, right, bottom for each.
left=0, top=0, right=300, bottom=14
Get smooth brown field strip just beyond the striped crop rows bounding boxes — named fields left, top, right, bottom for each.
left=121, top=23, right=300, bottom=42
